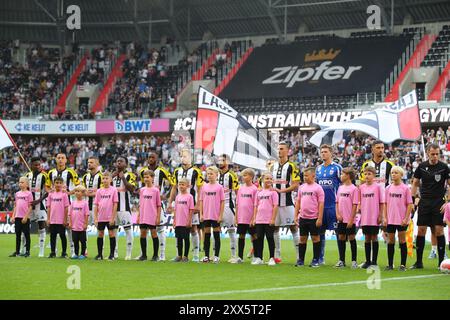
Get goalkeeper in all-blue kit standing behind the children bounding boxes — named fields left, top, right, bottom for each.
left=316, top=144, right=342, bottom=265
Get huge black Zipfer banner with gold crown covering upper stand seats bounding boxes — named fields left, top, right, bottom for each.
left=220, top=37, right=410, bottom=99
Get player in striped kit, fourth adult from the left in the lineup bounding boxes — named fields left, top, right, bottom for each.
left=112, top=156, right=137, bottom=260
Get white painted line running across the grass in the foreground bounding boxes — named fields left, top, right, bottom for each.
left=136, top=274, right=448, bottom=300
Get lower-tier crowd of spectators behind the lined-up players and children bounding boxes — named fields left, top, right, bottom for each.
left=0, top=127, right=450, bottom=211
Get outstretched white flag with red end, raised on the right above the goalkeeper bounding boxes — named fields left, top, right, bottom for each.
left=309, top=91, right=422, bottom=146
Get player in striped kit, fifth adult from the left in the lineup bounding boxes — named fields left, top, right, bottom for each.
left=139, top=151, right=175, bottom=261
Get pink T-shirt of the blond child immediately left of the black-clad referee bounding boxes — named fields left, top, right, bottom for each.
left=386, top=183, right=412, bottom=225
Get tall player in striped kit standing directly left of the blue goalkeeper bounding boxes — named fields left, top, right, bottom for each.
left=272, top=141, right=300, bottom=263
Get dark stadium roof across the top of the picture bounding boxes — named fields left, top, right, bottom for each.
left=0, top=0, right=450, bottom=43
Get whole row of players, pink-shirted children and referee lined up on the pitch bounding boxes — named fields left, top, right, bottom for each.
left=7, top=143, right=450, bottom=270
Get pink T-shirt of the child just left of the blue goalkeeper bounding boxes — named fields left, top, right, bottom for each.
left=297, top=182, right=325, bottom=219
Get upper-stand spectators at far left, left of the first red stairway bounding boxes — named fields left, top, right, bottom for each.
left=0, top=41, right=74, bottom=119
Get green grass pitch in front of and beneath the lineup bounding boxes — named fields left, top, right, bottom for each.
left=0, top=235, right=450, bottom=300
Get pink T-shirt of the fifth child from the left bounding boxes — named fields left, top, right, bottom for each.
left=139, top=187, right=161, bottom=226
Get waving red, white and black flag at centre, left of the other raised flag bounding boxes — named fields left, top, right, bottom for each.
left=194, top=87, right=272, bottom=170
